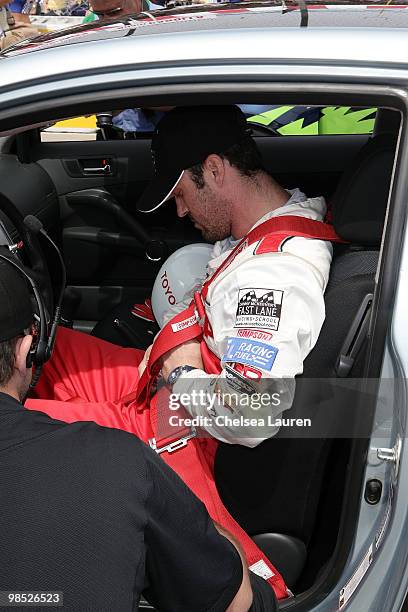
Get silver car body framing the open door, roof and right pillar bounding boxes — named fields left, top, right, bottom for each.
left=0, top=5, right=408, bottom=612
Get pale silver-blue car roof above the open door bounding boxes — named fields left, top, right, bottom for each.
left=0, top=2, right=408, bottom=92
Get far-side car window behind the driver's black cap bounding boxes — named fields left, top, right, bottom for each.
left=41, top=104, right=377, bottom=142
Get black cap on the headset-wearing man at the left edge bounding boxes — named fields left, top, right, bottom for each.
left=0, top=259, right=34, bottom=342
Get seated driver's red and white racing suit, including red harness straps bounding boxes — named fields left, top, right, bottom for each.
left=26, top=189, right=337, bottom=598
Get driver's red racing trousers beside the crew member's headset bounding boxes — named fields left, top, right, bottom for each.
left=25, top=327, right=150, bottom=440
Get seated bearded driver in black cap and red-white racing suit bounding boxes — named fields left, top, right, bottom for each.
left=27, top=106, right=336, bottom=597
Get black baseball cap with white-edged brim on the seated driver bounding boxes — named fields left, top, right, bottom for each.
left=137, top=105, right=250, bottom=212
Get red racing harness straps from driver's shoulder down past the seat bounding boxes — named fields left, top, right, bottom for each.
left=132, top=215, right=343, bottom=599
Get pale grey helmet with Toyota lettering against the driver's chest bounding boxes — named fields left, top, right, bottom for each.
left=152, top=243, right=213, bottom=327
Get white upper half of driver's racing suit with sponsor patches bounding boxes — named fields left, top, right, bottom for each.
left=162, top=190, right=332, bottom=446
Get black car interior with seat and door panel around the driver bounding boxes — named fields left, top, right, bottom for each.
left=0, top=100, right=401, bottom=607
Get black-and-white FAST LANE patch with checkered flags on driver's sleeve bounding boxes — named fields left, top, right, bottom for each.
left=235, top=288, right=283, bottom=331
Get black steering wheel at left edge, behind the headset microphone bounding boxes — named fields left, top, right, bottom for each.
left=0, top=194, right=54, bottom=314
